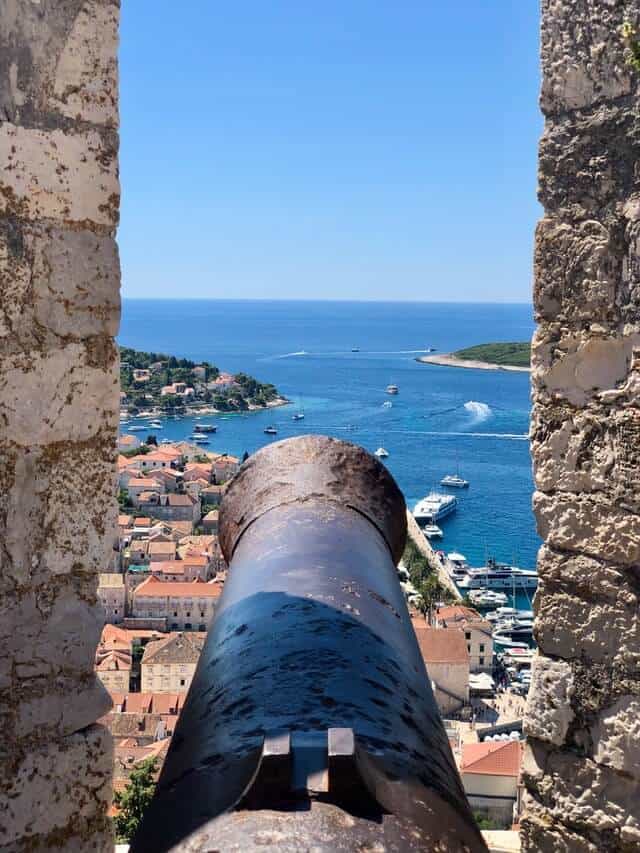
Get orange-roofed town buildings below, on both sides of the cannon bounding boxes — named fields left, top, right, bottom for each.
left=101, top=434, right=529, bottom=829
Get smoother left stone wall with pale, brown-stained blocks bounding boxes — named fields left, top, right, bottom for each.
left=0, top=0, right=120, bottom=851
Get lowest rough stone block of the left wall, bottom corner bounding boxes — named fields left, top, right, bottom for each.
left=0, top=726, right=113, bottom=846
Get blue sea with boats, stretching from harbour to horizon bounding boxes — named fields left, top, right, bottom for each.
left=119, top=300, right=540, bottom=580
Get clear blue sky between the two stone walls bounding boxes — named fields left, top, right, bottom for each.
left=118, top=0, right=542, bottom=302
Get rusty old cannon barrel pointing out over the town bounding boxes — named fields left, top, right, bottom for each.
left=131, top=436, right=486, bottom=853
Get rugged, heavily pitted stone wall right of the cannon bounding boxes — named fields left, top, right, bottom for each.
left=522, top=0, right=640, bottom=853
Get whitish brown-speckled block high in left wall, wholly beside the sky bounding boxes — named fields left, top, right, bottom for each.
left=0, top=122, right=120, bottom=226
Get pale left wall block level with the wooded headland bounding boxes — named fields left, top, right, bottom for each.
left=0, top=338, right=120, bottom=446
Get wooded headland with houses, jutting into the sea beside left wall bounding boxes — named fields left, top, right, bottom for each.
left=120, top=347, right=289, bottom=415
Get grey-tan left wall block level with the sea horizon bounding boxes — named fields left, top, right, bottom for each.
left=0, top=219, right=120, bottom=352
